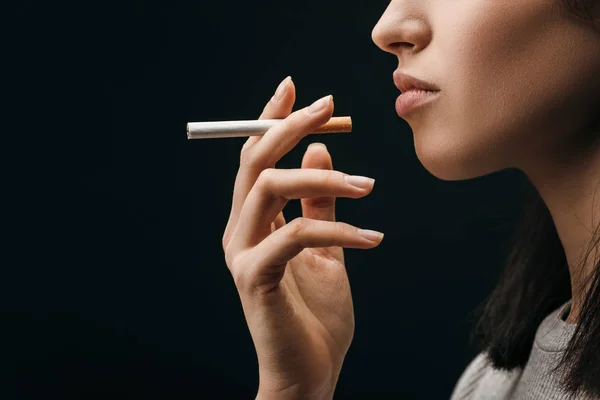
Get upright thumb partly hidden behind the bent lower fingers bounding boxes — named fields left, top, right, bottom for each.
left=300, top=143, right=335, bottom=222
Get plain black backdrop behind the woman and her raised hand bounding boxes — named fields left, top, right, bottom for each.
left=2, top=0, right=524, bottom=399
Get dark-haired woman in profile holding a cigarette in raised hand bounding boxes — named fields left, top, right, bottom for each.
left=223, top=0, right=600, bottom=399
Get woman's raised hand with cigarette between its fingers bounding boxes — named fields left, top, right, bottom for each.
left=223, top=78, right=383, bottom=399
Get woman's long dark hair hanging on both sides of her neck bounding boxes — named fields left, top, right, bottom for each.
left=473, top=0, right=600, bottom=397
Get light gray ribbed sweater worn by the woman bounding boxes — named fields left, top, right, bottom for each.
left=450, top=301, right=590, bottom=400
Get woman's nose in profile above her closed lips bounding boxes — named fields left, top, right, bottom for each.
left=371, top=0, right=433, bottom=57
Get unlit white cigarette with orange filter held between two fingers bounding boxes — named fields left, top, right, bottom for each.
left=187, top=117, right=352, bottom=139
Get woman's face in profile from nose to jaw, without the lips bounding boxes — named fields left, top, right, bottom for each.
left=372, top=0, right=600, bottom=180
